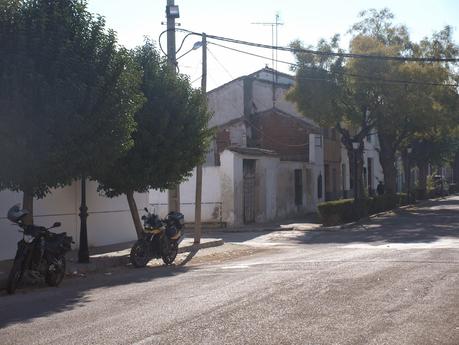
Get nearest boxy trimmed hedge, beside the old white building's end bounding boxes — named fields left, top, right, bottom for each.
left=318, top=199, right=358, bottom=226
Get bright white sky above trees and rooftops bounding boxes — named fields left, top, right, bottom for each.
left=88, top=0, right=459, bottom=90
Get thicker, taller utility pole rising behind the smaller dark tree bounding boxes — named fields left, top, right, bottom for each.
left=166, top=0, right=180, bottom=212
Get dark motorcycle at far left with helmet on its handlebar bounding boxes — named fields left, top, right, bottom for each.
left=6, top=205, right=73, bottom=294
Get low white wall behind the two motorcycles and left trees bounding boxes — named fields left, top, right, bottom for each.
left=0, top=181, right=148, bottom=260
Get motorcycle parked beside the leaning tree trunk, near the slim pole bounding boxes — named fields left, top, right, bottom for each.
left=130, top=208, right=184, bottom=267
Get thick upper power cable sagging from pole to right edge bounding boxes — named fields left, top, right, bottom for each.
left=177, top=29, right=459, bottom=62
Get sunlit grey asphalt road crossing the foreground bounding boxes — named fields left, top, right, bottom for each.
left=0, top=197, right=459, bottom=345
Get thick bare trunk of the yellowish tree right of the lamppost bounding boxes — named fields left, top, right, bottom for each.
left=378, top=133, right=397, bottom=194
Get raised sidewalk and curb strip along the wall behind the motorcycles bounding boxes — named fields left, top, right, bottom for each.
left=0, top=239, right=225, bottom=290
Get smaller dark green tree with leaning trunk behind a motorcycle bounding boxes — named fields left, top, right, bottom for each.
left=97, top=40, right=211, bottom=238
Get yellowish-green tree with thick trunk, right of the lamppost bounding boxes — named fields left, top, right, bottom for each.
left=351, top=9, right=459, bottom=193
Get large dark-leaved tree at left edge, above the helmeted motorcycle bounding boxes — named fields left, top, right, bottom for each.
left=0, top=0, right=142, bottom=221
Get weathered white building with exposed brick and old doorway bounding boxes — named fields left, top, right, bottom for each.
left=150, top=68, right=324, bottom=226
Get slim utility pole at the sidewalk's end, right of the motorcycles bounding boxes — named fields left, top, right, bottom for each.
left=194, top=33, right=207, bottom=244
